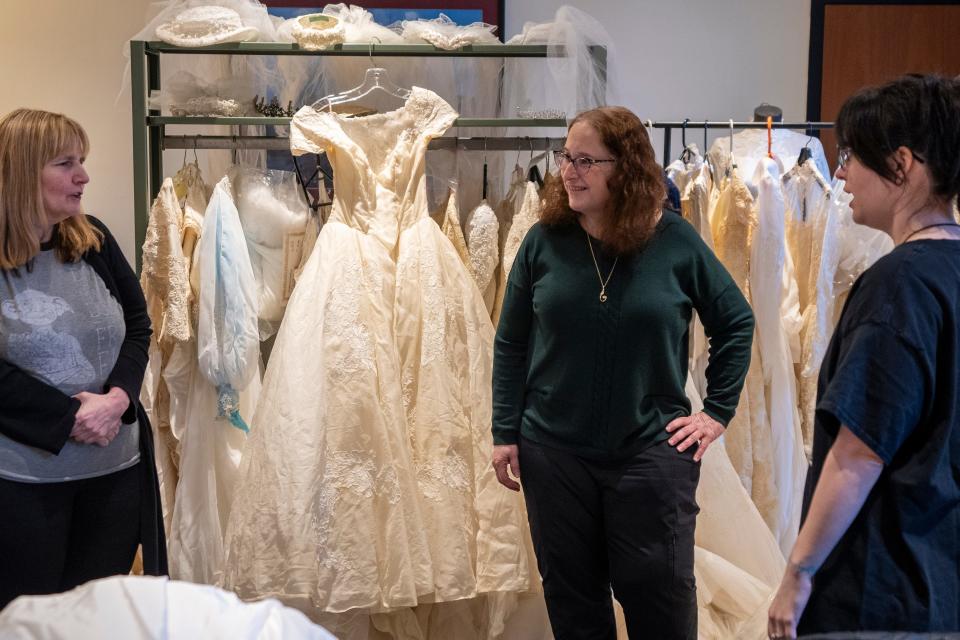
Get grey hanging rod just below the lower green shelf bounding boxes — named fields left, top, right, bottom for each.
left=162, top=135, right=566, bottom=151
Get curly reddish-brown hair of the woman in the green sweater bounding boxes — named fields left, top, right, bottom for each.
left=540, top=107, right=667, bottom=254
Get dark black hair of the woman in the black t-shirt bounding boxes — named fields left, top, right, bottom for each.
left=836, top=74, right=960, bottom=200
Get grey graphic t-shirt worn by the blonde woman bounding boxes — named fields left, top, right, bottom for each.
left=0, top=250, right=140, bottom=482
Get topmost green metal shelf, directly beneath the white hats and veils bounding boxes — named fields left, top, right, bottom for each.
left=144, top=42, right=563, bottom=58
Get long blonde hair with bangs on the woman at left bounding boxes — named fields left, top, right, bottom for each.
left=0, top=109, right=103, bottom=270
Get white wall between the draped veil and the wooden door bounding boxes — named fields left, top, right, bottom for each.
left=505, top=0, right=810, bottom=165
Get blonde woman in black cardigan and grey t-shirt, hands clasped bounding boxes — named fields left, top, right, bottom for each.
left=0, top=109, right=166, bottom=609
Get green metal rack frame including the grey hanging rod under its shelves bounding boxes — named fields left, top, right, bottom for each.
left=130, top=40, right=607, bottom=271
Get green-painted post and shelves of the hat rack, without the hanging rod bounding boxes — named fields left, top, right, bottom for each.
left=130, top=40, right=607, bottom=272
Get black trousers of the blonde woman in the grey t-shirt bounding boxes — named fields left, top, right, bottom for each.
left=0, top=463, right=142, bottom=609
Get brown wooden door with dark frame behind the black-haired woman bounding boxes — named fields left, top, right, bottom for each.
left=807, top=0, right=960, bottom=170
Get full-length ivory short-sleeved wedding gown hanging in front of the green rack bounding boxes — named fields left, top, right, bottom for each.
left=224, top=87, right=538, bottom=616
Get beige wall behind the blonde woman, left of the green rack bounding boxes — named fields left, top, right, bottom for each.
left=0, top=0, right=149, bottom=259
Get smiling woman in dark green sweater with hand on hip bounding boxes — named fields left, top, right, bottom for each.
left=493, top=107, right=753, bottom=640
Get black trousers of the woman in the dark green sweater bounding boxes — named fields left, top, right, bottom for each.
left=520, top=439, right=700, bottom=640
